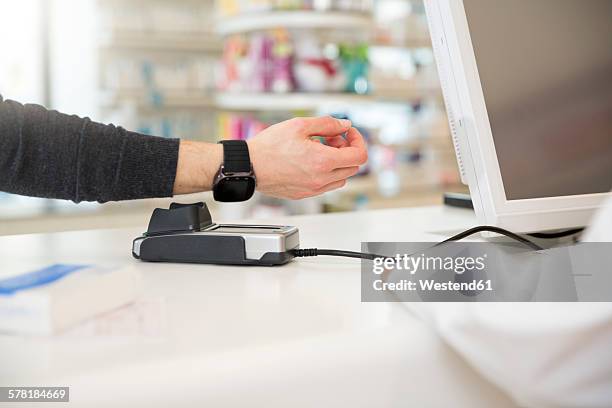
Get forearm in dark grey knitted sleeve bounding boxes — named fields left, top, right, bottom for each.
left=0, top=98, right=179, bottom=202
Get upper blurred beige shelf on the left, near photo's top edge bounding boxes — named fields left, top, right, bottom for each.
left=100, top=31, right=222, bottom=53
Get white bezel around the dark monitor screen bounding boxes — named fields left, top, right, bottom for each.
left=425, top=0, right=612, bottom=232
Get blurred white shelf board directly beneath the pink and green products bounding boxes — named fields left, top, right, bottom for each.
left=215, top=92, right=372, bottom=111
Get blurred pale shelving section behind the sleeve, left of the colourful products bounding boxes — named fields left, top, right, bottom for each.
left=97, top=0, right=222, bottom=141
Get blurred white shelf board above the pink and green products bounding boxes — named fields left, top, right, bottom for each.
left=215, top=10, right=373, bottom=35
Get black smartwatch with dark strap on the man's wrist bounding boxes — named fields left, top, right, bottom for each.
left=213, top=140, right=255, bottom=202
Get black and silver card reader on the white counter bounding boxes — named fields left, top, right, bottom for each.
left=132, top=202, right=300, bottom=266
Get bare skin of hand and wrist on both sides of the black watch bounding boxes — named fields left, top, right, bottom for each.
left=174, top=117, right=368, bottom=199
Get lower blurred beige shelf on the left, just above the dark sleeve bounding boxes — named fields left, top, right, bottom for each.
left=101, top=89, right=215, bottom=109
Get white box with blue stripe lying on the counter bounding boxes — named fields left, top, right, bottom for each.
left=0, top=264, right=140, bottom=334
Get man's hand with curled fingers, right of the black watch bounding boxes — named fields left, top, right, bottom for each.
left=248, top=117, right=368, bottom=199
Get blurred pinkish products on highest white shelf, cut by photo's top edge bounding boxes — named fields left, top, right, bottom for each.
left=217, top=0, right=372, bottom=16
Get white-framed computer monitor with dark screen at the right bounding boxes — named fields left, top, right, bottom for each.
left=425, top=0, right=612, bottom=232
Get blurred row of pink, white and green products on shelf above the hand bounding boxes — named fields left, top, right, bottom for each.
left=218, top=29, right=369, bottom=94
